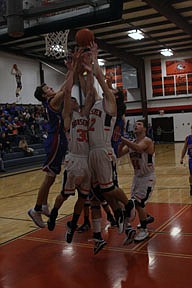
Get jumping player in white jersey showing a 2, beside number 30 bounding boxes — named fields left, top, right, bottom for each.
left=88, top=43, right=139, bottom=254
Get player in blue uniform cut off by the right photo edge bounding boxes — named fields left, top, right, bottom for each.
left=180, top=126, right=192, bottom=196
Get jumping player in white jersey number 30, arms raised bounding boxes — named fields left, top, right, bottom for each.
left=47, top=50, right=94, bottom=243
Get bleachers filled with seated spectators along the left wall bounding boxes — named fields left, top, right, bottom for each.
left=0, top=103, right=47, bottom=176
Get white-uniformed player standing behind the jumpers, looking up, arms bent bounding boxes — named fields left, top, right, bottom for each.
left=118, top=120, right=155, bottom=244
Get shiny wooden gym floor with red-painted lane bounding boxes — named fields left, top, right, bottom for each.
left=0, top=143, right=192, bottom=288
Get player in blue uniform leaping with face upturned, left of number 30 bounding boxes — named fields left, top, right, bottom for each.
left=28, top=71, right=73, bottom=228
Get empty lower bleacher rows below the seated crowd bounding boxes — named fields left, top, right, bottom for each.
left=3, top=143, right=45, bottom=173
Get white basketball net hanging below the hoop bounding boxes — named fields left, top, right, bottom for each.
left=45, top=30, right=69, bottom=59
